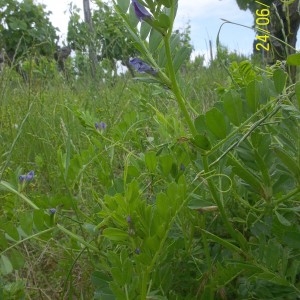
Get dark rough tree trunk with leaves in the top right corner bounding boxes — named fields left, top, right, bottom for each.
left=236, top=0, right=300, bottom=81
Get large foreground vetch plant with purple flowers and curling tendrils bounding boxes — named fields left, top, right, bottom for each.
left=89, top=0, right=300, bottom=300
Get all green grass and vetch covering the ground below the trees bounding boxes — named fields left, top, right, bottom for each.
left=0, top=0, right=300, bottom=300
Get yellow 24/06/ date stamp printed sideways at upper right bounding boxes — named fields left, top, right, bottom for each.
left=255, top=1, right=270, bottom=51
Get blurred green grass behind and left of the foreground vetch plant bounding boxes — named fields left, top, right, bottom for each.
left=0, top=59, right=230, bottom=299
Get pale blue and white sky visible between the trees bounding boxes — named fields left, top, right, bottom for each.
left=36, top=0, right=255, bottom=60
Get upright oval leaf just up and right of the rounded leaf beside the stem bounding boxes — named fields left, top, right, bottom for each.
left=223, top=91, right=243, bottom=126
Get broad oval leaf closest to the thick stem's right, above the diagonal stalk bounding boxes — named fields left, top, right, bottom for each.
left=205, top=107, right=226, bottom=139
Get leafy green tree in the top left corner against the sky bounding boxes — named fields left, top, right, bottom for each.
left=0, top=0, right=57, bottom=64
